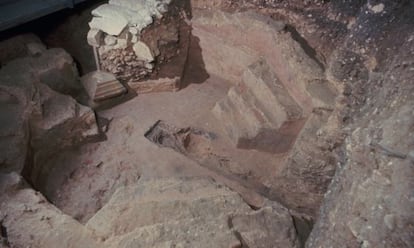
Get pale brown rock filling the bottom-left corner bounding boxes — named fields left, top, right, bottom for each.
left=0, top=172, right=99, bottom=247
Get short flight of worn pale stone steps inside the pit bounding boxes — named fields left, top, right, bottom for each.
left=213, top=59, right=304, bottom=153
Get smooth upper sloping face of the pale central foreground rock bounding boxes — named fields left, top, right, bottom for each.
left=86, top=176, right=249, bottom=238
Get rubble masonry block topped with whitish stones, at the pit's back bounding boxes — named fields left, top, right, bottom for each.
left=87, top=0, right=179, bottom=87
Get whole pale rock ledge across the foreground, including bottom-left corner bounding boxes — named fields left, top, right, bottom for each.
left=0, top=174, right=298, bottom=248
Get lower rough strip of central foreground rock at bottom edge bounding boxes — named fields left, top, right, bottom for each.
left=107, top=214, right=240, bottom=248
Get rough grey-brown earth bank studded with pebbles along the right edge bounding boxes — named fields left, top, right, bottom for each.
left=307, top=1, right=414, bottom=247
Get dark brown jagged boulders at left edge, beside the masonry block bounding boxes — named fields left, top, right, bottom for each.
left=0, top=36, right=99, bottom=177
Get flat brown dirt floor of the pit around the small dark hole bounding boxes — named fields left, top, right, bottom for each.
left=45, top=74, right=284, bottom=223
